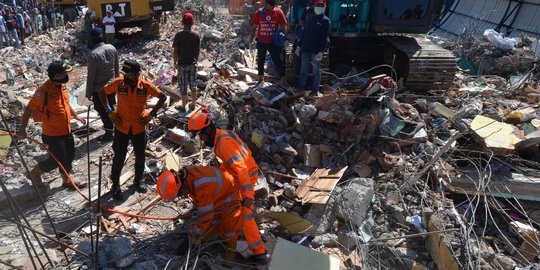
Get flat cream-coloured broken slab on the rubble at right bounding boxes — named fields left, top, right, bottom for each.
left=470, top=115, right=524, bottom=155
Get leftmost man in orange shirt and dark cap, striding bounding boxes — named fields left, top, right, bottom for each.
left=17, top=61, right=86, bottom=188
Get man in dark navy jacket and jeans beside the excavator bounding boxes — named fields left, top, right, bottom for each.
left=297, top=0, right=330, bottom=95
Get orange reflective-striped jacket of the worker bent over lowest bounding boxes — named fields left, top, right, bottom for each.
left=186, top=166, right=241, bottom=238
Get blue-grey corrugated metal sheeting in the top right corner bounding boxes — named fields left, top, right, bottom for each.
left=431, top=0, right=540, bottom=53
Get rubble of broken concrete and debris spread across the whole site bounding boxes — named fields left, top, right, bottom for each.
left=0, top=2, right=540, bottom=269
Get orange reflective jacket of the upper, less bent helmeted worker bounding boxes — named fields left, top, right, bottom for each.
left=214, top=128, right=259, bottom=199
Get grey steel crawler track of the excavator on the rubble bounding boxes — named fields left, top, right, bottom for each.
left=388, top=35, right=458, bottom=90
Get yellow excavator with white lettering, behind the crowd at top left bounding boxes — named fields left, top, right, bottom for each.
left=88, top=0, right=174, bottom=38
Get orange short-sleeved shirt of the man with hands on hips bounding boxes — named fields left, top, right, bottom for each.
left=103, top=77, right=161, bottom=135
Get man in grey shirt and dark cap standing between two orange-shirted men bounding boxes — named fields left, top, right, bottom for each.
left=86, top=28, right=120, bottom=141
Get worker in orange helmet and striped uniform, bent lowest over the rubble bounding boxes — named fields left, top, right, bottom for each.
left=156, top=166, right=242, bottom=255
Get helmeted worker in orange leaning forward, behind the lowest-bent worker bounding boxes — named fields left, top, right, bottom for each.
left=188, top=111, right=267, bottom=264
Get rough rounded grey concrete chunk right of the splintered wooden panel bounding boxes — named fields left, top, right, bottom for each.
left=335, top=178, right=373, bottom=226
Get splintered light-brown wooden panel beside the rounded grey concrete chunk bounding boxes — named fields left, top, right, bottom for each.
left=296, top=167, right=347, bottom=204
